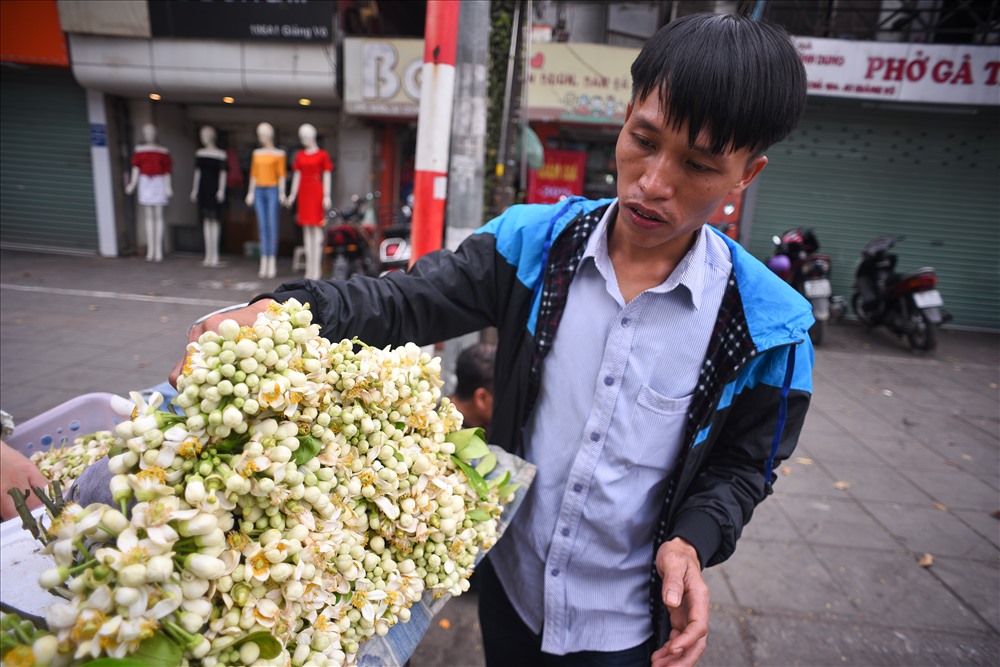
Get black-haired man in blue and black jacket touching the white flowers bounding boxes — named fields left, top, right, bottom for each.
left=175, top=15, right=813, bottom=666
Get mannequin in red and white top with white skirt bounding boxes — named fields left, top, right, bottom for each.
left=125, top=123, right=174, bottom=262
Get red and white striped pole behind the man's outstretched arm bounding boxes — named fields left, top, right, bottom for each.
left=410, top=0, right=460, bottom=265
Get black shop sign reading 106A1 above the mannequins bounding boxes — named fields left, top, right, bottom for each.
left=147, top=0, right=334, bottom=43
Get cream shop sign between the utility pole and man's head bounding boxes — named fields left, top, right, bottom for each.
left=528, top=43, right=639, bottom=126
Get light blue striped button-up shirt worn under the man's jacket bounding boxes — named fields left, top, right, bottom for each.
left=490, top=202, right=732, bottom=655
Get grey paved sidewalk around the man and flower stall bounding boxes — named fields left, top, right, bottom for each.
left=0, top=250, right=1000, bottom=667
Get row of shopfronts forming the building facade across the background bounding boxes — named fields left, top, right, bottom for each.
left=0, top=0, right=1000, bottom=329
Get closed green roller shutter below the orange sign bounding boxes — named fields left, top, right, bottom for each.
left=0, top=67, right=97, bottom=251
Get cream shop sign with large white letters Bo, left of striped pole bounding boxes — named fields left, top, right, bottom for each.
left=344, top=37, right=424, bottom=118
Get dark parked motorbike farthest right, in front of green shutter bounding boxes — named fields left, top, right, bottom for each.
left=851, top=235, right=951, bottom=351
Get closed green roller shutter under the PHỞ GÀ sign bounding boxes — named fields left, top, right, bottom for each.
left=750, top=97, right=1000, bottom=330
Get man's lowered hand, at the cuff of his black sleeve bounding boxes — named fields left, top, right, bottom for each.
left=652, top=537, right=709, bottom=667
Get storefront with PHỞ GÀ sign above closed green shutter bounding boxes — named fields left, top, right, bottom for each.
left=744, top=39, right=1000, bottom=330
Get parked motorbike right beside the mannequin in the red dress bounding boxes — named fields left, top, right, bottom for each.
left=323, top=192, right=378, bottom=280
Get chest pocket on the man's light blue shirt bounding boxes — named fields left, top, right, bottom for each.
left=616, top=385, right=694, bottom=472
